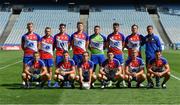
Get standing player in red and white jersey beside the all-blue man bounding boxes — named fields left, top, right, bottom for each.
left=125, top=24, right=144, bottom=58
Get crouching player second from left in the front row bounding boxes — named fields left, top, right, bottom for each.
left=54, top=51, right=75, bottom=88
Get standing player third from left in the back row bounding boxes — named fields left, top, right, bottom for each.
left=54, top=24, right=70, bottom=66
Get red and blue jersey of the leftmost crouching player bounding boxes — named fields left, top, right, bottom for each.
left=26, top=59, right=45, bottom=70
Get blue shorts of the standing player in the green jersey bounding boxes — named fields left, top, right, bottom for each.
left=91, top=54, right=105, bottom=65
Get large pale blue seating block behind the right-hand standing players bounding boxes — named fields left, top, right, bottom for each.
left=88, top=5, right=163, bottom=43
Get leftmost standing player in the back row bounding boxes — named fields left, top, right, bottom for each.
left=21, top=22, right=40, bottom=84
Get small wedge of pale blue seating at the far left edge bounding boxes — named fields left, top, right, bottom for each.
left=0, top=12, right=11, bottom=36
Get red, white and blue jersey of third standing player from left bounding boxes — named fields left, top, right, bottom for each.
left=54, top=33, right=71, bottom=56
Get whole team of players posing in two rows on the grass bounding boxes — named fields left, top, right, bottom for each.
left=21, top=22, right=170, bottom=89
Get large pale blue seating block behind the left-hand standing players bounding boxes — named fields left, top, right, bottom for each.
left=5, top=6, right=80, bottom=45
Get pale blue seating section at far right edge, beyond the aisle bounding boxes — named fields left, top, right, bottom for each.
left=158, top=5, right=180, bottom=44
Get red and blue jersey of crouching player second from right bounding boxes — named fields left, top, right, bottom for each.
left=125, top=57, right=144, bottom=72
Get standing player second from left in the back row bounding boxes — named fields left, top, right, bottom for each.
left=40, top=27, right=54, bottom=87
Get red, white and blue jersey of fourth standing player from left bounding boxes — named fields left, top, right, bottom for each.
left=71, top=32, right=89, bottom=54
